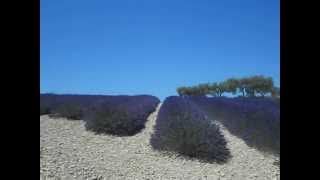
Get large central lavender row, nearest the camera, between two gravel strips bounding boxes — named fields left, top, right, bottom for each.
left=150, top=96, right=230, bottom=162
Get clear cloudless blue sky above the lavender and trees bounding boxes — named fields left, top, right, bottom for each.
left=40, top=0, right=280, bottom=99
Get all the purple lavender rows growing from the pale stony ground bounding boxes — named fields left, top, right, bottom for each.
left=40, top=94, right=280, bottom=162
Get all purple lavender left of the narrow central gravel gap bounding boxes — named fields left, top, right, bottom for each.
left=40, top=94, right=160, bottom=136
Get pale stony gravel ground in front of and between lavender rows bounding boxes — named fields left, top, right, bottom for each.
left=40, top=106, right=280, bottom=180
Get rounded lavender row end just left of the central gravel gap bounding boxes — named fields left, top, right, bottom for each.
left=84, top=95, right=160, bottom=136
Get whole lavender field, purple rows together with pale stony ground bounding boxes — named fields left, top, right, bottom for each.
left=40, top=94, right=280, bottom=179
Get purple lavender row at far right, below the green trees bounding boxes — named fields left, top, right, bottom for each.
left=189, top=97, right=280, bottom=153
